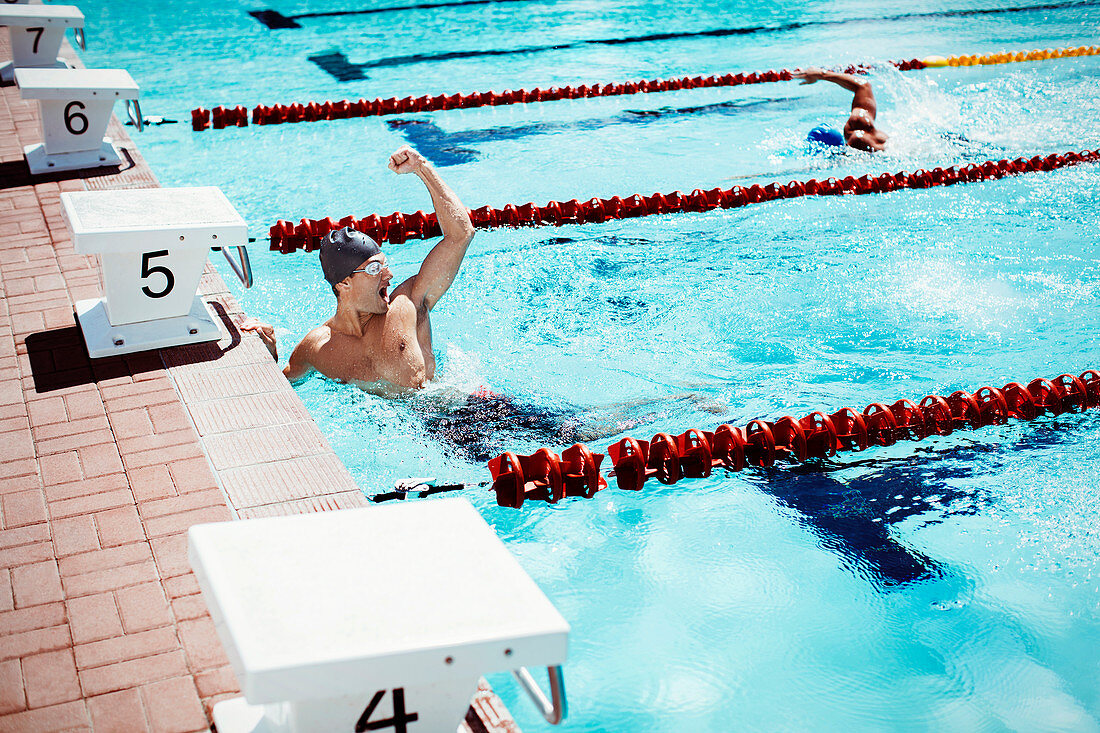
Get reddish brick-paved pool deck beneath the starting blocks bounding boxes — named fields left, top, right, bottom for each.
left=0, top=38, right=517, bottom=733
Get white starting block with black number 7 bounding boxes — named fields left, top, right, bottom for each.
left=0, top=0, right=85, bottom=81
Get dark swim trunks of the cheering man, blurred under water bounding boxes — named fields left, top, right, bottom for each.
left=424, top=391, right=576, bottom=461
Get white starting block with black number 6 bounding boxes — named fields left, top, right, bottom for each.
left=15, top=68, right=142, bottom=175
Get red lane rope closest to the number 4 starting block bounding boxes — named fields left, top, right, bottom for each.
left=488, top=369, right=1100, bottom=507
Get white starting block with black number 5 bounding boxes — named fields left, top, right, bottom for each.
left=61, top=186, right=252, bottom=359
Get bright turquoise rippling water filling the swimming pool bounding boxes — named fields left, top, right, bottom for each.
left=83, top=0, right=1100, bottom=731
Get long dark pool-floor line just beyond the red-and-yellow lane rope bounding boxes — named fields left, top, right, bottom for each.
left=308, top=0, right=1100, bottom=81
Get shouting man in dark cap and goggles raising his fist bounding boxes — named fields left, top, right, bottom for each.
left=241, top=145, right=474, bottom=390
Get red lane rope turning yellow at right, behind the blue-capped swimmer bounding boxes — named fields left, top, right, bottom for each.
left=191, top=46, right=1100, bottom=132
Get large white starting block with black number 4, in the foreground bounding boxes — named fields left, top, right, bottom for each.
left=188, top=499, right=569, bottom=733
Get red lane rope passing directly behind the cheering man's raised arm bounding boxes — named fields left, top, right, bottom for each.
left=270, top=150, right=1100, bottom=253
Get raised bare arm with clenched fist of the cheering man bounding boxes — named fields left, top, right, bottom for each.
left=389, top=145, right=474, bottom=310
